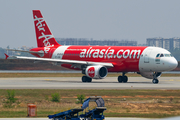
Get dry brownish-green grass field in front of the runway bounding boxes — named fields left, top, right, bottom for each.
left=0, top=89, right=180, bottom=118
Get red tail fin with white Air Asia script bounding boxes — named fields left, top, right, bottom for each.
left=33, top=10, right=59, bottom=47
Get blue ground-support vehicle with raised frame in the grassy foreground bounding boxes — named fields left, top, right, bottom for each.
left=48, top=96, right=106, bottom=120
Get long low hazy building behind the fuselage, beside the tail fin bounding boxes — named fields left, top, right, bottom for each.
left=56, top=38, right=137, bottom=46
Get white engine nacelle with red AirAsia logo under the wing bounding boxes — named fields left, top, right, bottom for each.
left=85, top=65, right=108, bottom=79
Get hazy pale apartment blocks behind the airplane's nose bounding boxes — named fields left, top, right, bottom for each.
left=146, top=38, right=180, bottom=50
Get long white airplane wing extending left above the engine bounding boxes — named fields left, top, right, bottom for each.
left=14, top=56, right=113, bottom=67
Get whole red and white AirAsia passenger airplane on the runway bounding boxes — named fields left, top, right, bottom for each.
left=6, top=10, right=178, bottom=84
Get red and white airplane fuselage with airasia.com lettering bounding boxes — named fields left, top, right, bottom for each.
left=29, top=46, right=177, bottom=72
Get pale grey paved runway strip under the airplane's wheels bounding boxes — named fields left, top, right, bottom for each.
left=0, top=77, right=180, bottom=89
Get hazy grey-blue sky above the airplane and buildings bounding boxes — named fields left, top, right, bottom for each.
left=0, top=0, right=180, bottom=48
